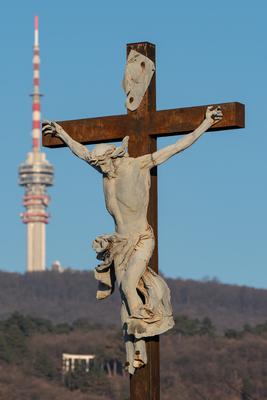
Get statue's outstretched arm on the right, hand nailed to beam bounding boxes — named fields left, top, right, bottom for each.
left=139, top=106, right=223, bottom=168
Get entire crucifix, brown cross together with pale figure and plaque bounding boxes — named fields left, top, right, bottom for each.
left=43, top=42, right=244, bottom=400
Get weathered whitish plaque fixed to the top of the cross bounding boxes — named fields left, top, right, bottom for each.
left=122, top=50, right=155, bottom=111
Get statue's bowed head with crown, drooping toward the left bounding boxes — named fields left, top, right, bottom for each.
left=90, top=136, right=129, bottom=173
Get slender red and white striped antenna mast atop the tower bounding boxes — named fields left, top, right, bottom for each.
left=32, top=16, right=41, bottom=153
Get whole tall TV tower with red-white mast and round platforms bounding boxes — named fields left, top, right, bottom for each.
left=19, top=16, right=54, bottom=272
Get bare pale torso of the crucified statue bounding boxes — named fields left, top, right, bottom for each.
left=104, top=157, right=150, bottom=234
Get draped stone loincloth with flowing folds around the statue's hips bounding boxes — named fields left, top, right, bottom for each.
left=93, top=227, right=174, bottom=339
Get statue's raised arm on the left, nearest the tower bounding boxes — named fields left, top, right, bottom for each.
left=42, top=121, right=91, bottom=162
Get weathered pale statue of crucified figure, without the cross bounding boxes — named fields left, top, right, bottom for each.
left=43, top=106, right=222, bottom=374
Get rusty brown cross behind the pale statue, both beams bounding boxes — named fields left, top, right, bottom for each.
left=43, top=42, right=245, bottom=400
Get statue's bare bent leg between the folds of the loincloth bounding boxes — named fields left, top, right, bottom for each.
left=121, top=238, right=154, bottom=318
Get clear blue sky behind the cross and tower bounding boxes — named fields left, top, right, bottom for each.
left=0, top=0, right=267, bottom=288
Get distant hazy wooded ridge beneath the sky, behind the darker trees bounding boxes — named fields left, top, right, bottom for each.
left=0, top=270, right=267, bottom=330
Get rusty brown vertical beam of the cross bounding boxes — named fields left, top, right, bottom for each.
left=127, top=42, right=160, bottom=400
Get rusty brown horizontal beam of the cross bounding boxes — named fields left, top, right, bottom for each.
left=43, top=102, right=245, bottom=147
